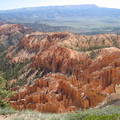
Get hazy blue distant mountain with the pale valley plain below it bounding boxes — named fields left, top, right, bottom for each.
left=0, top=5, right=120, bottom=34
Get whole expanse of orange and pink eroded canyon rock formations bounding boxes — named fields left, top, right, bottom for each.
left=0, top=25, right=120, bottom=113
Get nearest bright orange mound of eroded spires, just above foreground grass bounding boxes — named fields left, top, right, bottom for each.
left=11, top=74, right=105, bottom=113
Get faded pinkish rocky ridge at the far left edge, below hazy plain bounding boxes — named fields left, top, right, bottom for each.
left=0, top=24, right=31, bottom=48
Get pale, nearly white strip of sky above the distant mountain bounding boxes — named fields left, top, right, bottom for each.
left=0, top=0, right=120, bottom=10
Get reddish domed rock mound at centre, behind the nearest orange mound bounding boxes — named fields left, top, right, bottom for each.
left=32, top=46, right=91, bottom=75
